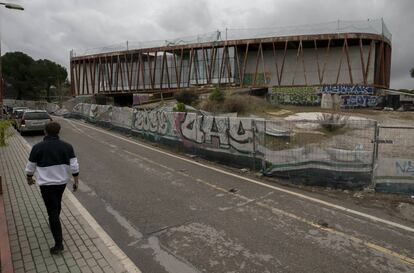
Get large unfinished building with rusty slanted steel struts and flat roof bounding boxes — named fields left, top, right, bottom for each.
left=70, top=19, right=391, bottom=106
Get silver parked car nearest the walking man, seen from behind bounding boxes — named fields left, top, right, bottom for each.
left=17, top=110, right=52, bottom=135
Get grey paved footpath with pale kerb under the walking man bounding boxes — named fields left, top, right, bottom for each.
left=0, top=133, right=140, bottom=273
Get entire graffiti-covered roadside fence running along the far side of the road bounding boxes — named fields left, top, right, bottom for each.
left=74, top=103, right=414, bottom=190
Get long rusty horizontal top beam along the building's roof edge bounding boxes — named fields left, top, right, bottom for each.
left=73, top=33, right=391, bottom=60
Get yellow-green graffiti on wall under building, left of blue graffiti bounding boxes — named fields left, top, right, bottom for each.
left=269, top=86, right=321, bottom=106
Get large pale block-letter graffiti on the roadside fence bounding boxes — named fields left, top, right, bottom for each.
left=132, top=110, right=254, bottom=153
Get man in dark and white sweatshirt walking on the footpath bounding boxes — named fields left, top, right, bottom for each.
left=26, top=122, right=79, bottom=254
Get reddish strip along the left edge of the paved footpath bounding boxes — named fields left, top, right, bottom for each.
left=0, top=176, right=13, bottom=273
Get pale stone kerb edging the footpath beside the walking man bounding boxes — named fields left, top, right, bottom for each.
left=22, top=134, right=142, bottom=273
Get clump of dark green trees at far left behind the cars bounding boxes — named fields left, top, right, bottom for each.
left=2, top=52, right=68, bottom=101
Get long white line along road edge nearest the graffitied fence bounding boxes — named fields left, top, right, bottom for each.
left=62, top=119, right=414, bottom=233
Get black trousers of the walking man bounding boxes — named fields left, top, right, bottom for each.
left=40, top=184, right=66, bottom=247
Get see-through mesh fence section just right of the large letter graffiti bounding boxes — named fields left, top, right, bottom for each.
left=261, top=120, right=377, bottom=187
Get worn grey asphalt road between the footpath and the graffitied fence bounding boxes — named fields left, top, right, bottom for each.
left=25, top=119, right=414, bottom=273
